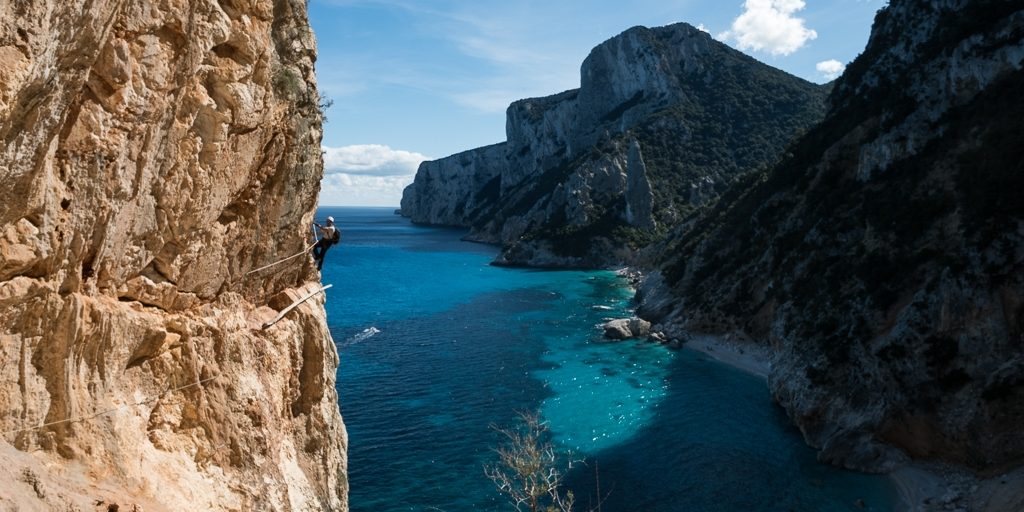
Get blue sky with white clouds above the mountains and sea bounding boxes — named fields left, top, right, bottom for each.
left=309, top=0, right=887, bottom=203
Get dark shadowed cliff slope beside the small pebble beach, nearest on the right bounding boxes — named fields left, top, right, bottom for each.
left=642, top=0, right=1024, bottom=470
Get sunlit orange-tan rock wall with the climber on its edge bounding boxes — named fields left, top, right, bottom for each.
left=0, top=0, right=347, bottom=510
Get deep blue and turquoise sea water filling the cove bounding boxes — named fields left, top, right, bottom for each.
left=318, top=208, right=897, bottom=512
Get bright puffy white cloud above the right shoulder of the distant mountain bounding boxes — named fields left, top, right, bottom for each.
left=717, top=0, right=818, bottom=55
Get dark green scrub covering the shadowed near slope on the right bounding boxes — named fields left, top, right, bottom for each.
left=645, top=2, right=1024, bottom=385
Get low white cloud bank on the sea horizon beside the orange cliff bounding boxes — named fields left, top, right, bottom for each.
left=319, top=144, right=430, bottom=206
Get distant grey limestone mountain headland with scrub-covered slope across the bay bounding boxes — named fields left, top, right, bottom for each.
left=401, top=24, right=826, bottom=266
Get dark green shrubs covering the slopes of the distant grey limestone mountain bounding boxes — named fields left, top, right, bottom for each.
left=476, top=23, right=829, bottom=265
